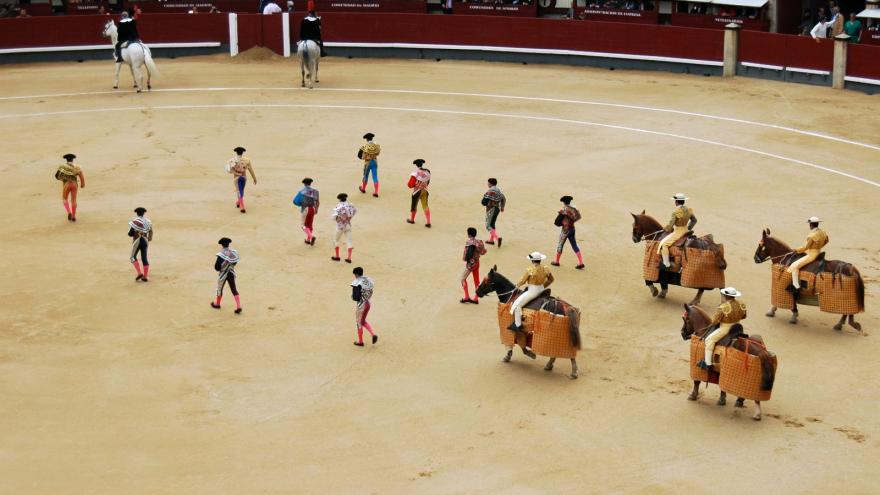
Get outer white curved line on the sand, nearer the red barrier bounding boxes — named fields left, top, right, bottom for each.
left=0, top=87, right=880, bottom=151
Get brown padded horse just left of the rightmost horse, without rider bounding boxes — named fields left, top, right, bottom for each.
left=630, top=210, right=727, bottom=304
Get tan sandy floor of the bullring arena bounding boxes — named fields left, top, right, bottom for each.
left=0, top=52, right=880, bottom=494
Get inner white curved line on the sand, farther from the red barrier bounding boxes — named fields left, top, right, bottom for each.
left=0, top=103, right=880, bottom=187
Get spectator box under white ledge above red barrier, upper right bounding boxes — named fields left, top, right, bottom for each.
left=671, top=0, right=770, bottom=31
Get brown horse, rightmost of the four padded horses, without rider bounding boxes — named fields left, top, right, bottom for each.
left=755, top=229, right=865, bottom=331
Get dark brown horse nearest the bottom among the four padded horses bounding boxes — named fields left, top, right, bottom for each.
left=681, top=304, right=776, bottom=421
